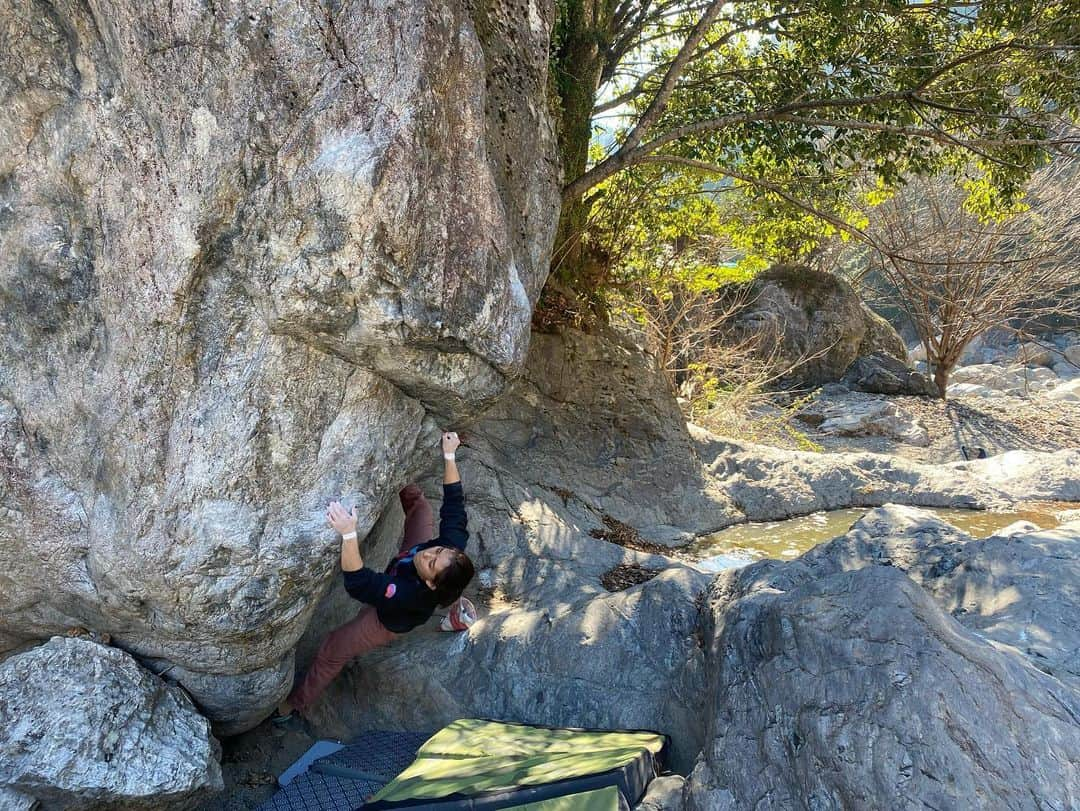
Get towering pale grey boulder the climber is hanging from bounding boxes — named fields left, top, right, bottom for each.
left=0, top=0, right=558, bottom=732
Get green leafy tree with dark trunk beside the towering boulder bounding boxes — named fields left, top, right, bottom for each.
left=552, top=0, right=1080, bottom=313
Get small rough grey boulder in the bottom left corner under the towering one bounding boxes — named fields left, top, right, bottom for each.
left=0, top=637, right=221, bottom=810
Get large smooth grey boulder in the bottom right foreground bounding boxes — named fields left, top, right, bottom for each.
left=686, top=563, right=1080, bottom=809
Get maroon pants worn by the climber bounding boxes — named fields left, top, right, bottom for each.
left=288, top=485, right=435, bottom=713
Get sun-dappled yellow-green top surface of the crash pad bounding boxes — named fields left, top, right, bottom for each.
left=372, top=719, right=665, bottom=811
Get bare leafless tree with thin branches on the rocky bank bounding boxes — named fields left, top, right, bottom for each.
left=866, top=159, right=1080, bottom=397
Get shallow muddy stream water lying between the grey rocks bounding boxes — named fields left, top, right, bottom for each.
left=683, top=501, right=1080, bottom=571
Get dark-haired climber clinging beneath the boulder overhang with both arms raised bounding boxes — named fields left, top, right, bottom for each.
left=274, top=431, right=473, bottom=724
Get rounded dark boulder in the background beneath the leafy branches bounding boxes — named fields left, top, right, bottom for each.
left=740, top=265, right=907, bottom=387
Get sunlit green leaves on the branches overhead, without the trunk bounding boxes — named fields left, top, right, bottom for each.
left=556, top=0, right=1080, bottom=304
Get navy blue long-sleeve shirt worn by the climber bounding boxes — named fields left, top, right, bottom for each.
left=345, top=482, right=469, bottom=634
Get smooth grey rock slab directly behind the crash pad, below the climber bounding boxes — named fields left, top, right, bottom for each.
left=311, top=567, right=710, bottom=769
